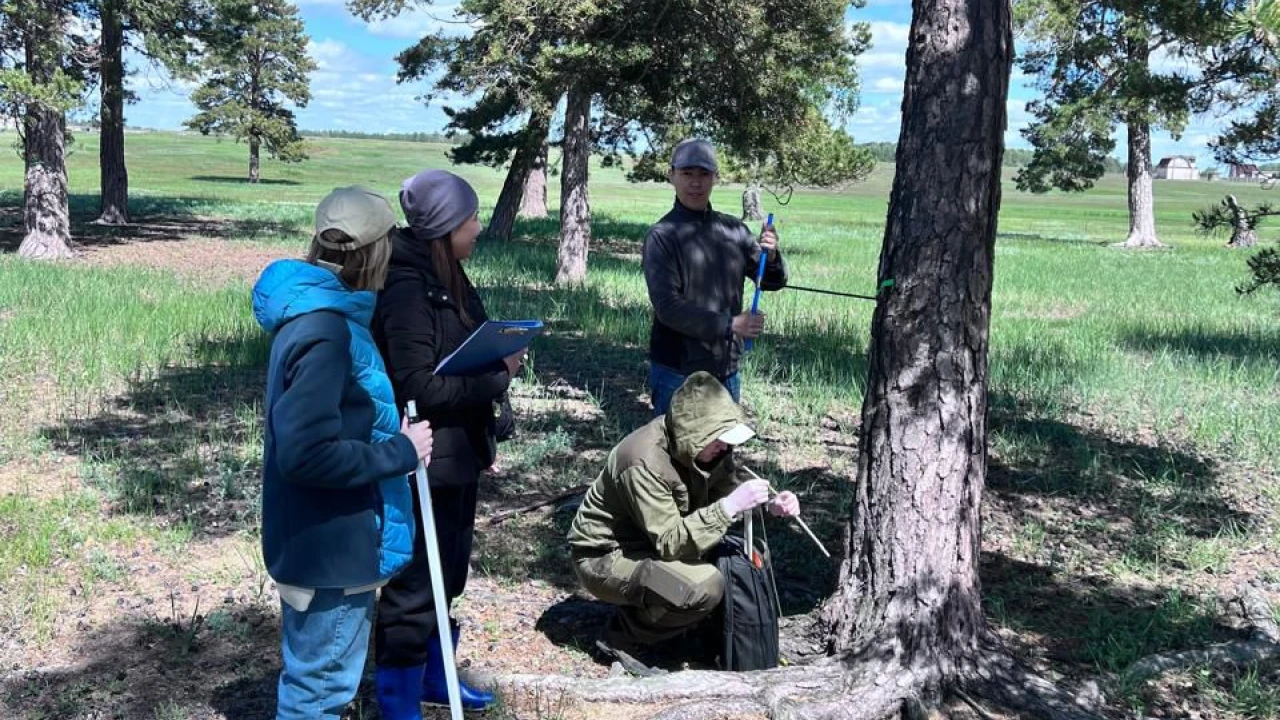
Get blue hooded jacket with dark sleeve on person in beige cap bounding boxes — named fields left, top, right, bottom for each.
left=253, top=260, right=417, bottom=588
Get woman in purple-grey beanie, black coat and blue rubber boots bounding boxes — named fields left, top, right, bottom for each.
left=372, top=170, right=522, bottom=720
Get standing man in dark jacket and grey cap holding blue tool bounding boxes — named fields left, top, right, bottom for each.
left=644, top=140, right=787, bottom=415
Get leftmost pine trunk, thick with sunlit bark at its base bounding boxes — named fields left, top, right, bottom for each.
left=18, top=4, right=72, bottom=260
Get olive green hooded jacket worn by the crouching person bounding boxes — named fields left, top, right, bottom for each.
left=568, top=373, right=746, bottom=561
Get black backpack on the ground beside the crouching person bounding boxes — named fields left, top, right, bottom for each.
left=710, top=520, right=778, bottom=670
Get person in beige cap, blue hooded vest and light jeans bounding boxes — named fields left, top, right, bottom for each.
left=253, top=187, right=431, bottom=720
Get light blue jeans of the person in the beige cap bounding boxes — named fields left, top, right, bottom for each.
left=275, top=589, right=375, bottom=720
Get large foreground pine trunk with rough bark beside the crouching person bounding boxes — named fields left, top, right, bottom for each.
left=823, top=0, right=1014, bottom=676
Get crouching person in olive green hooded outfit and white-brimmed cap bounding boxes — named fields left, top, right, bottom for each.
left=568, top=373, right=800, bottom=650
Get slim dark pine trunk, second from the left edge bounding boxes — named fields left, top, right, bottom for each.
left=96, top=0, right=129, bottom=225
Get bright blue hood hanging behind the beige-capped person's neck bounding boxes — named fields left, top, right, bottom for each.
left=253, top=260, right=378, bottom=333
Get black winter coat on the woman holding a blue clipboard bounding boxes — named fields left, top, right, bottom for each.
left=371, top=229, right=511, bottom=487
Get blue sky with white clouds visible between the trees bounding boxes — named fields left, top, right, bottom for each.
left=127, top=0, right=1216, bottom=167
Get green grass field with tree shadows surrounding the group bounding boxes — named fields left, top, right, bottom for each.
left=0, top=133, right=1280, bottom=717
